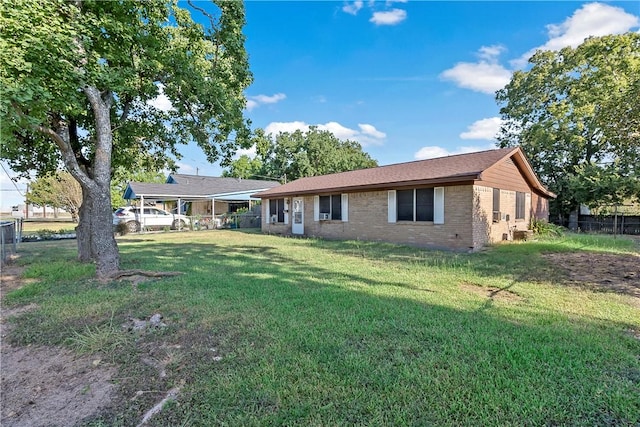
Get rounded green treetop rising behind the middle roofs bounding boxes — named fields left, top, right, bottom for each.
left=225, top=126, right=378, bottom=181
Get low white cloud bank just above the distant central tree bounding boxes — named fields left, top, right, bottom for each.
left=264, top=121, right=387, bottom=147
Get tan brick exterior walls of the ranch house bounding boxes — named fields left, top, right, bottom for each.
left=262, top=185, right=531, bottom=250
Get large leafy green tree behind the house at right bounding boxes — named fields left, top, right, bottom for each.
left=496, top=33, right=640, bottom=221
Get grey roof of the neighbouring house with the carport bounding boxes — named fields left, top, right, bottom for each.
left=124, top=174, right=280, bottom=200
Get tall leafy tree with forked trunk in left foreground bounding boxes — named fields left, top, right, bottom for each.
left=0, top=0, right=251, bottom=278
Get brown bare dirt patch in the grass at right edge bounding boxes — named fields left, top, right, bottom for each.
left=543, top=252, right=640, bottom=298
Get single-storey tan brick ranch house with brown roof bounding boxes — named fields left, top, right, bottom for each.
left=254, top=147, right=555, bottom=250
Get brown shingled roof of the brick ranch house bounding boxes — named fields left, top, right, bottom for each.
left=254, top=147, right=555, bottom=198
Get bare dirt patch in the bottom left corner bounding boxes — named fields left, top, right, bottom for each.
left=0, top=264, right=116, bottom=427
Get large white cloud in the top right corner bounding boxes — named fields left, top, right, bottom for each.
left=512, top=3, right=640, bottom=68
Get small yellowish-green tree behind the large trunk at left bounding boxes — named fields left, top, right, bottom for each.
left=27, top=172, right=82, bottom=222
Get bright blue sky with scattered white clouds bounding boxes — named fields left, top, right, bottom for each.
left=0, top=1, right=640, bottom=210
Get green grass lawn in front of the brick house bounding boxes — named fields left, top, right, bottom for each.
left=3, top=231, right=640, bottom=426
